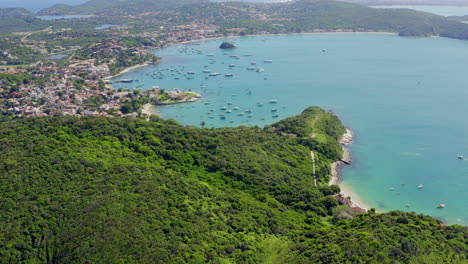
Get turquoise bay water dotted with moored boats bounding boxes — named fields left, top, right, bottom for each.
left=114, top=34, right=468, bottom=224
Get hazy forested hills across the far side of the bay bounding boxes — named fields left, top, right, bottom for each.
left=34, top=0, right=468, bottom=39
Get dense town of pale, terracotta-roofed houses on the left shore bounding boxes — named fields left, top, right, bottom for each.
left=0, top=25, right=229, bottom=116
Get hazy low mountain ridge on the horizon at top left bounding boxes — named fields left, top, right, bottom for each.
left=38, top=0, right=209, bottom=15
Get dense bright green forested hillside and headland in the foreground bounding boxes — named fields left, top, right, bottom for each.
left=0, top=108, right=468, bottom=263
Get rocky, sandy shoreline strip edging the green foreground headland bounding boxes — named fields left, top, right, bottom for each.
left=329, top=128, right=370, bottom=212
